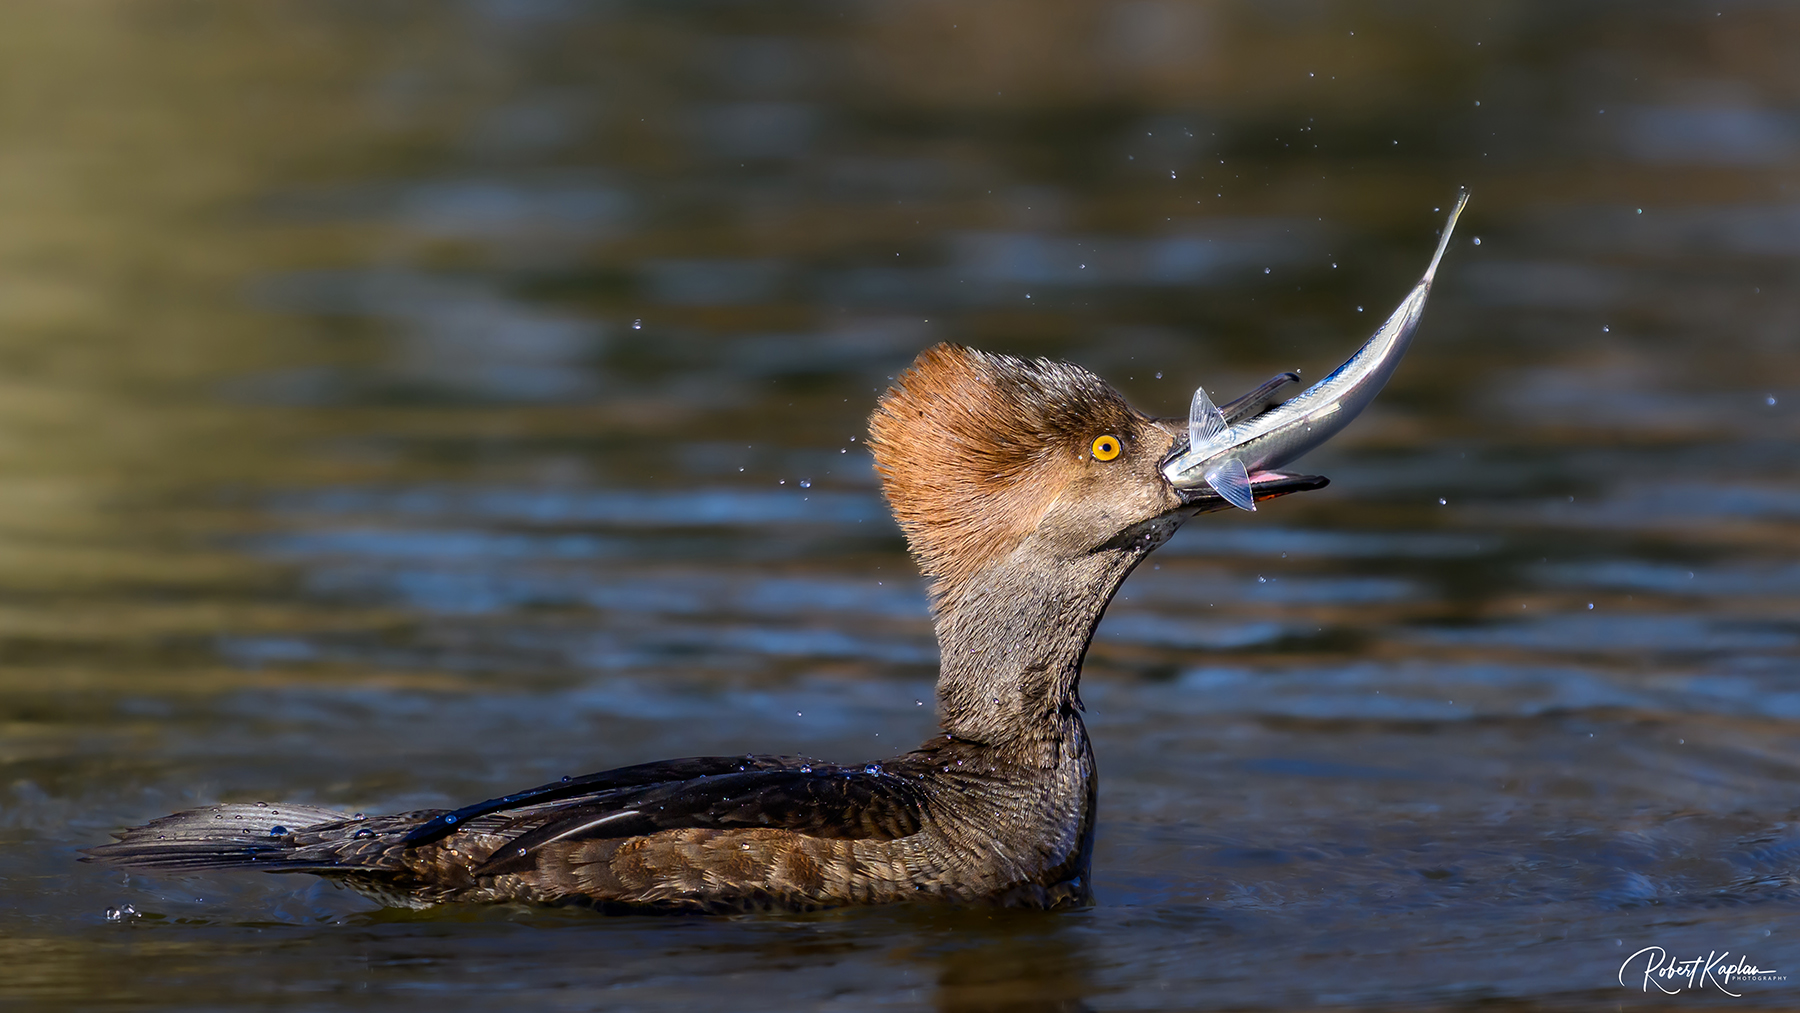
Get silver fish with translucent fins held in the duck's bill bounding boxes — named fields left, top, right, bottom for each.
left=1163, top=193, right=1469, bottom=511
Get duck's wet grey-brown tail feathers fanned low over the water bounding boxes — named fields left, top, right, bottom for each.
left=83, top=802, right=353, bottom=873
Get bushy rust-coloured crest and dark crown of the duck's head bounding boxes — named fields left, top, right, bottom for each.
left=869, top=344, right=1134, bottom=601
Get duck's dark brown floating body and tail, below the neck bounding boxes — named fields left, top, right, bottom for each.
left=88, top=738, right=1093, bottom=910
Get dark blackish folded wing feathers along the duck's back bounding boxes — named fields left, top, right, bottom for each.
left=473, top=765, right=925, bottom=876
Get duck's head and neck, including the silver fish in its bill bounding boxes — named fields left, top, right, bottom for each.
left=869, top=194, right=1462, bottom=741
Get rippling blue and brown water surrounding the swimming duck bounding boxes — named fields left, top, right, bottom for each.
left=0, top=0, right=1800, bottom=1009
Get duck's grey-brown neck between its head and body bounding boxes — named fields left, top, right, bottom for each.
left=936, top=536, right=1166, bottom=763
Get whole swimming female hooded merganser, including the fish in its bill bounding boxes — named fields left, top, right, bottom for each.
left=88, top=198, right=1465, bottom=910
